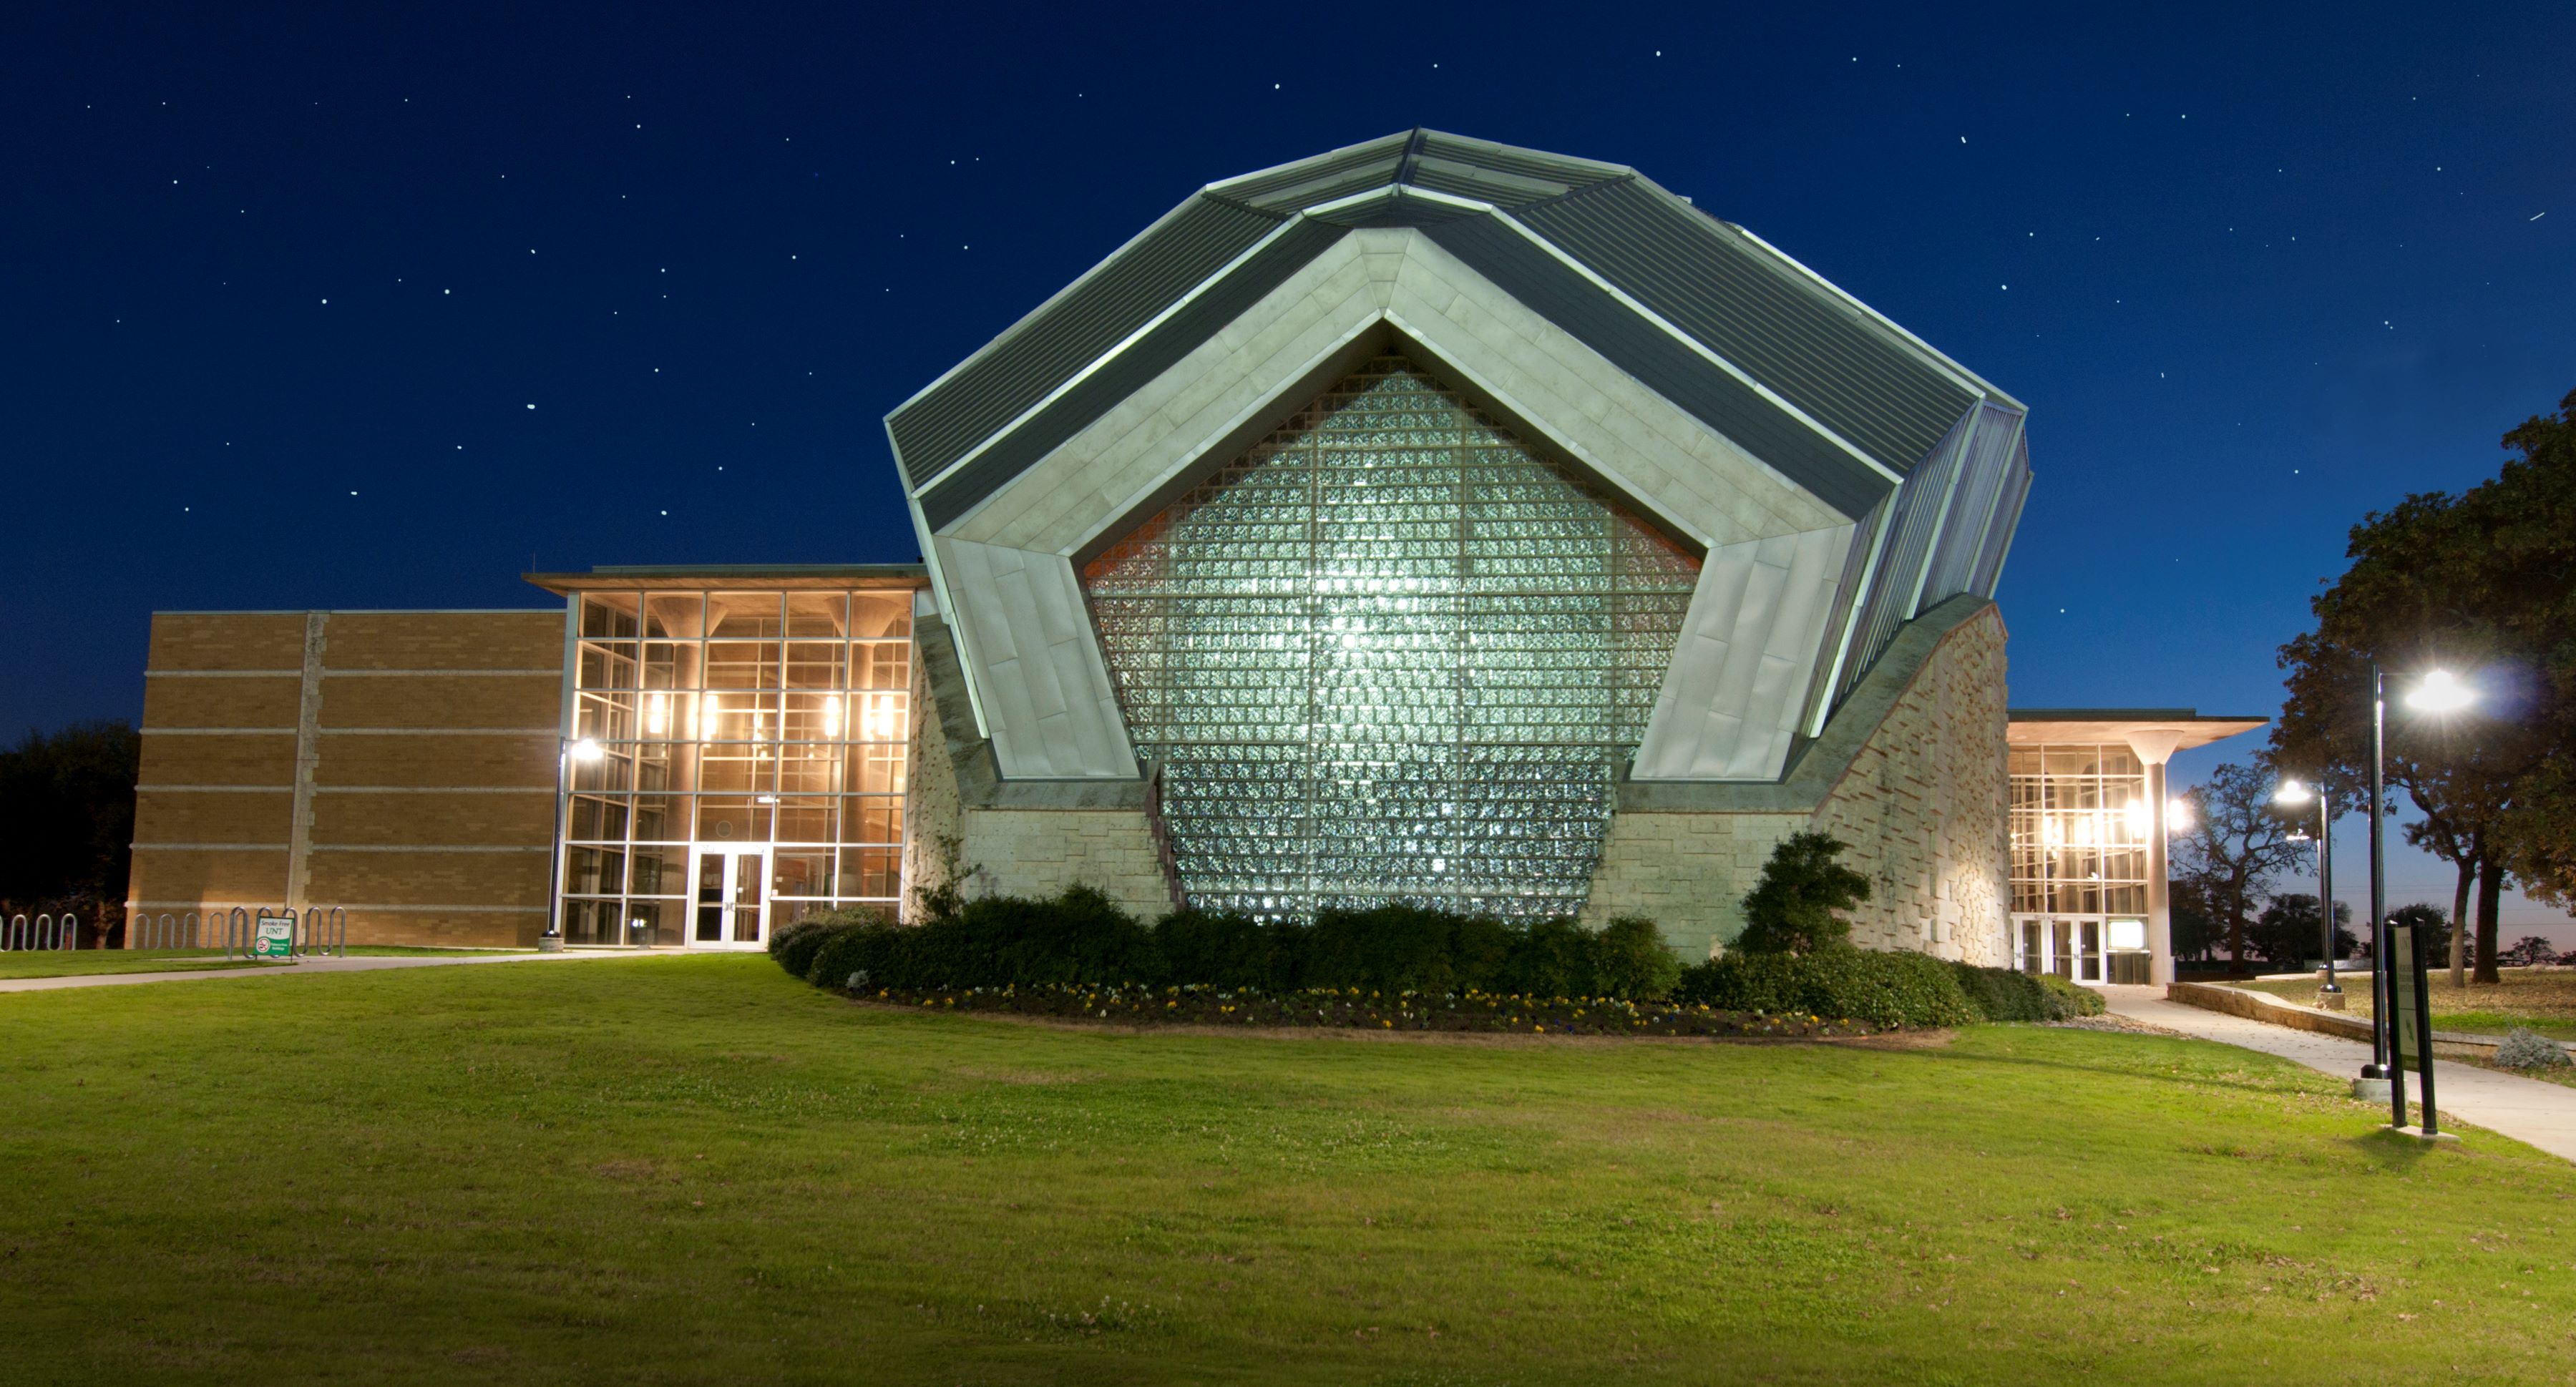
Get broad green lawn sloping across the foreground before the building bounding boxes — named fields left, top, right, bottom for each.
left=0, top=957, right=2576, bottom=1384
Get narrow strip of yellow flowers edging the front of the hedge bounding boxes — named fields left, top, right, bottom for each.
left=837, top=983, right=1885, bottom=1037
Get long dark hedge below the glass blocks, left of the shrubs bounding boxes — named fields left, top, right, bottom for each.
left=770, top=886, right=1682, bottom=1001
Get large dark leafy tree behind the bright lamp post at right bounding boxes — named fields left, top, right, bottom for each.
left=2272, top=393, right=2576, bottom=983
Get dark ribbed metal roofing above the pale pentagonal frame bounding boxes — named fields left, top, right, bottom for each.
left=886, top=129, right=2019, bottom=530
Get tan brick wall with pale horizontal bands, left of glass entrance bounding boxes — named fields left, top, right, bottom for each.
left=129, top=610, right=564, bottom=944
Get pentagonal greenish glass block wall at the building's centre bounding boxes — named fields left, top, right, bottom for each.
left=1085, top=358, right=1700, bottom=918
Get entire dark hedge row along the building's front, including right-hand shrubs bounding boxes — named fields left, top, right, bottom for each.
left=770, top=888, right=2102, bottom=1026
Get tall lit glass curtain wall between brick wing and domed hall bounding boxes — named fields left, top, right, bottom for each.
left=562, top=589, right=912, bottom=944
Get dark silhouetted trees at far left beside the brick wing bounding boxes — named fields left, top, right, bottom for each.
left=0, top=723, right=142, bottom=936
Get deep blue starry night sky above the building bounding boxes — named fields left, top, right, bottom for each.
left=15, top=3, right=2576, bottom=942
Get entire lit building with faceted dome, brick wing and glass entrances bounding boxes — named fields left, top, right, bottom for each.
left=129, top=131, right=2257, bottom=981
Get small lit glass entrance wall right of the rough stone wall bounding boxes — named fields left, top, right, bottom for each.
left=2009, top=744, right=2156, bottom=983
